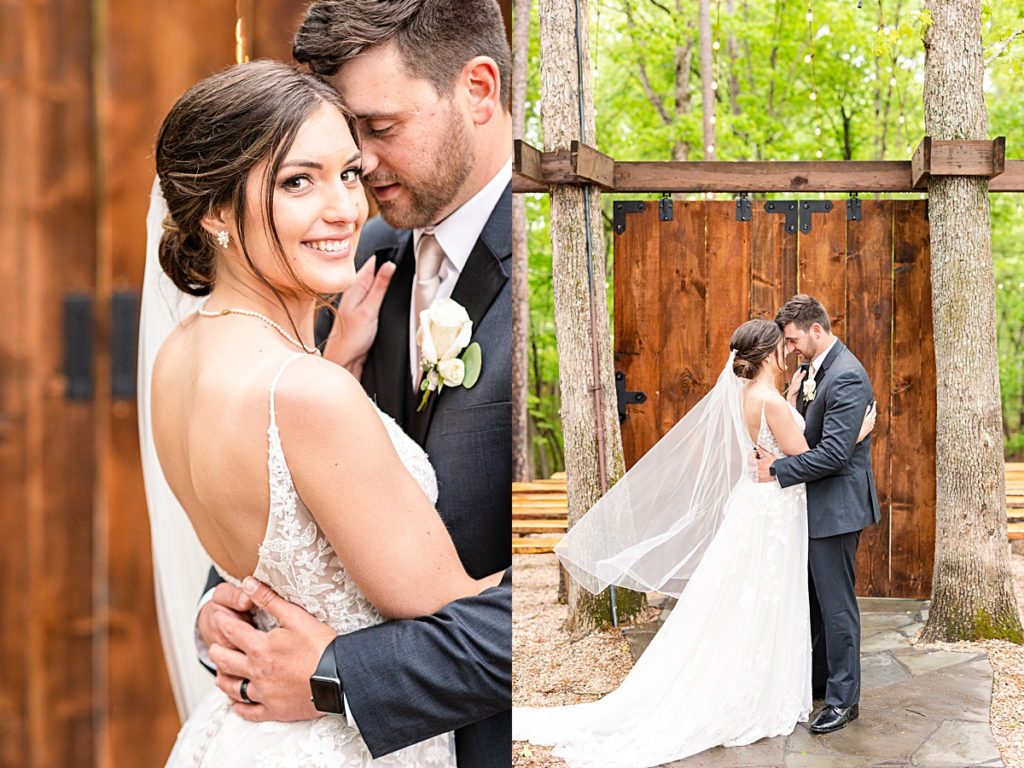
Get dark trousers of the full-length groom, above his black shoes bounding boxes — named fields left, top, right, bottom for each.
left=807, top=530, right=860, bottom=708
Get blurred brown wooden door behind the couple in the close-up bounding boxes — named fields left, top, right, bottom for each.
left=0, top=0, right=308, bottom=768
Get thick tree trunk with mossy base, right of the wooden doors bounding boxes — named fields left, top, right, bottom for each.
left=923, top=0, right=1024, bottom=642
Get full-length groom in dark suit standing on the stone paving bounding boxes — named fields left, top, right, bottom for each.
left=758, top=294, right=880, bottom=733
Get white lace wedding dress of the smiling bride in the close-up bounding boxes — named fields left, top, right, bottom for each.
left=167, top=353, right=456, bottom=768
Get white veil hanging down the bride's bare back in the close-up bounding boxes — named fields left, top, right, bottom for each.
left=138, top=179, right=213, bottom=721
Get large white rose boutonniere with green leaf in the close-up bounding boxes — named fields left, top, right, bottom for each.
left=416, top=299, right=483, bottom=413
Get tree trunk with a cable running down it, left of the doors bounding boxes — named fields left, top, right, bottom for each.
left=540, top=0, right=644, bottom=636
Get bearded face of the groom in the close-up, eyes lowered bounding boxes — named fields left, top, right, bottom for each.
left=332, top=45, right=473, bottom=229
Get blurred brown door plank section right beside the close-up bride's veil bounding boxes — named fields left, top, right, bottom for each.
left=96, top=0, right=236, bottom=768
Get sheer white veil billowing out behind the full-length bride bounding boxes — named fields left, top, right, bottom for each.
left=555, top=352, right=754, bottom=596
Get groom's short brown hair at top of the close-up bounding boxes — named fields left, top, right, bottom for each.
left=292, top=0, right=512, bottom=112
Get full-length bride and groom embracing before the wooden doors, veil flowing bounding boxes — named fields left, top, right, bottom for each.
left=513, top=295, right=879, bottom=768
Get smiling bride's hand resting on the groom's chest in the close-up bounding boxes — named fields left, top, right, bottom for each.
left=324, top=256, right=395, bottom=379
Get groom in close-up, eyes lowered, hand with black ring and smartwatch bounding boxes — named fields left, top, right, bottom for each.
left=198, top=0, right=512, bottom=768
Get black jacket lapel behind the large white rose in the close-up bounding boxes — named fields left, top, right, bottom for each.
left=409, top=184, right=512, bottom=445
